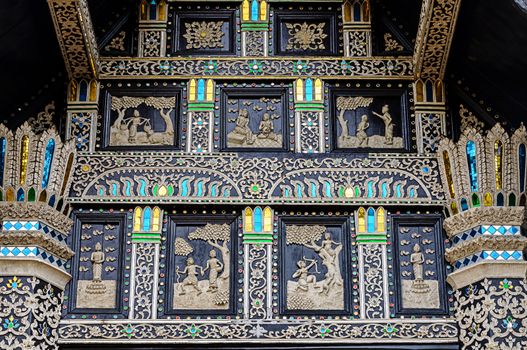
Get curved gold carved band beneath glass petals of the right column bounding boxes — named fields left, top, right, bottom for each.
left=443, top=207, right=525, bottom=237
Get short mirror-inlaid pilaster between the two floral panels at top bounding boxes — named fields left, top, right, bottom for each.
left=241, top=0, right=269, bottom=57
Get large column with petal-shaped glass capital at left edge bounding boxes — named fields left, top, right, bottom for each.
left=0, top=123, right=75, bottom=349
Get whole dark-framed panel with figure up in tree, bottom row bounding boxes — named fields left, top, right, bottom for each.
left=279, top=216, right=351, bottom=315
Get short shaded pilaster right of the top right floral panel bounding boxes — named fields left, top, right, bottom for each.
left=342, top=0, right=372, bottom=57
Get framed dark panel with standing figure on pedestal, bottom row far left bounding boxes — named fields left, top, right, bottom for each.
left=65, top=211, right=129, bottom=318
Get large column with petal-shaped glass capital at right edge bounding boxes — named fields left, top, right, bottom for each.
left=438, top=124, right=527, bottom=349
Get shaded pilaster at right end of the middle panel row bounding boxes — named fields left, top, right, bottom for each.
left=414, top=79, right=446, bottom=154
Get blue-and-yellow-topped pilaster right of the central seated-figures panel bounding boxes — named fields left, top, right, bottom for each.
left=294, top=78, right=325, bottom=153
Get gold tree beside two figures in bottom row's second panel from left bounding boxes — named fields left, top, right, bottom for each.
left=188, top=224, right=231, bottom=279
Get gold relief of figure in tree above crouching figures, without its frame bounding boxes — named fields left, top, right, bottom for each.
left=286, top=225, right=344, bottom=310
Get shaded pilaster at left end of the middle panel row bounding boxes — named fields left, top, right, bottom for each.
left=66, top=79, right=99, bottom=152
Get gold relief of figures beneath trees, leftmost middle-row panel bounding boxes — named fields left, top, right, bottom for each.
left=110, top=96, right=176, bottom=146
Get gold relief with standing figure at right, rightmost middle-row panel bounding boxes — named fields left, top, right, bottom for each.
left=337, top=96, right=403, bottom=148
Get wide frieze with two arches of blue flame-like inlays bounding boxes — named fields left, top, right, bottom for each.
left=70, top=152, right=444, bottom=204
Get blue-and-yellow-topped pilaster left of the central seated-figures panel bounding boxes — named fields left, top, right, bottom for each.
left=186, top=79, right=215, bottom=153
